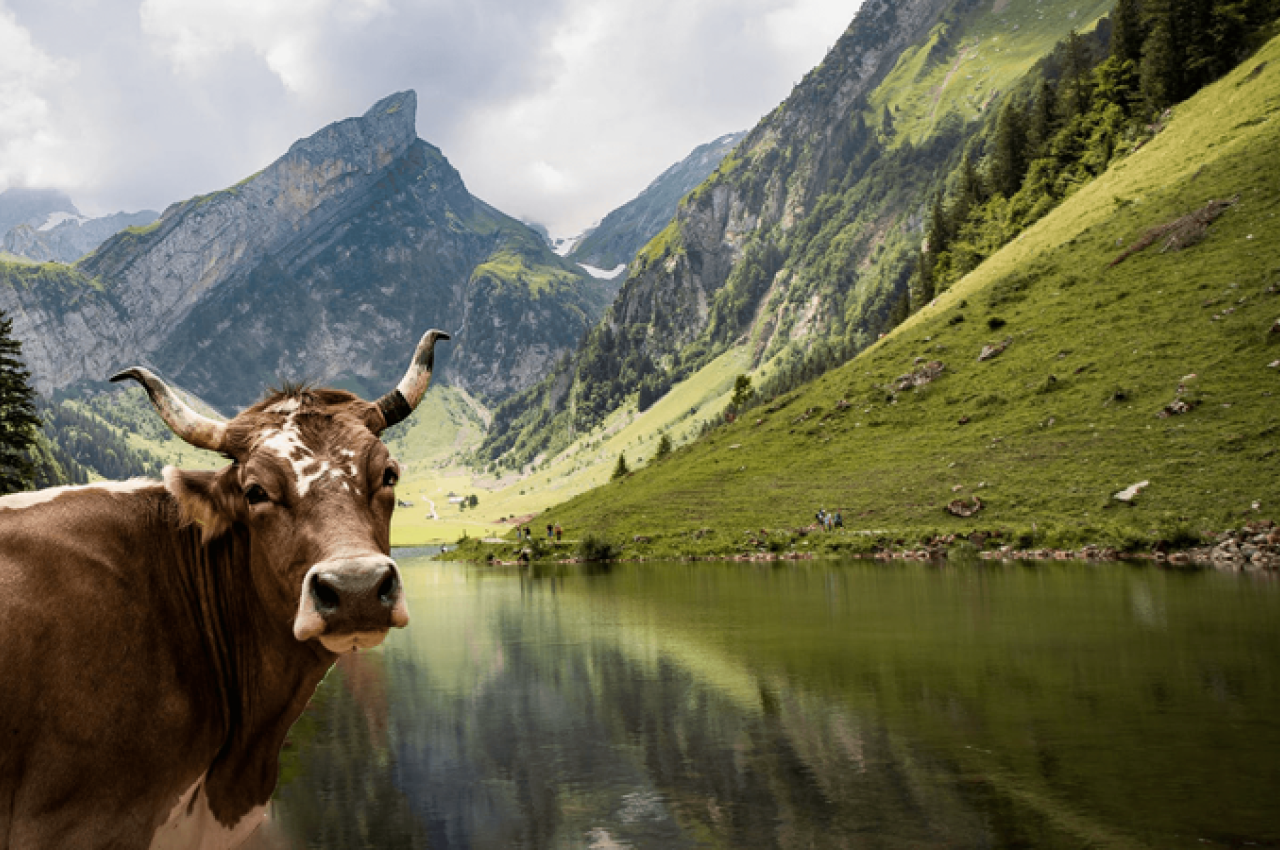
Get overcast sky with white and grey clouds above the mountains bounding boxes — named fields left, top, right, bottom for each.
left=0, top=0, right=860, bottom=236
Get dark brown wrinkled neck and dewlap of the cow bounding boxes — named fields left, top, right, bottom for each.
left=162, top=514, right=334, bottom=826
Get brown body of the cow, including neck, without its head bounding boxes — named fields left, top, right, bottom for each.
left=0, top=481, right=333, bottom=850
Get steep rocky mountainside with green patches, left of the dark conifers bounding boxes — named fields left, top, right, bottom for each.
left=477, top=0, right=1111, bottom=467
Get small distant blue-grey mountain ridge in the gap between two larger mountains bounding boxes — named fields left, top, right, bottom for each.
left=567, top=132, right=746, bottom=271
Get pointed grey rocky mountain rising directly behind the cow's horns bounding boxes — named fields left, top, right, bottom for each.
left=0, top=91, right=613, bottom=408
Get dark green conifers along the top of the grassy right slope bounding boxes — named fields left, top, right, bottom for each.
left=916, top=0, right=1280, bottom=302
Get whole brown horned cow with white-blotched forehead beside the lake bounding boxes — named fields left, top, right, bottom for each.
left=0, top=330, right=449, bottom=850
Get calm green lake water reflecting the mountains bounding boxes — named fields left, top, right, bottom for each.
left=264, top=553, right=1280, bottom=850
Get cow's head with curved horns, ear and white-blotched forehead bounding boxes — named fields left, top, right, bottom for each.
left=111, top=330, right=449, bottom=653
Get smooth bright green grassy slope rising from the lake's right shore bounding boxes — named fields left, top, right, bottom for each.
left=529, top=33, right=1280, bottom=550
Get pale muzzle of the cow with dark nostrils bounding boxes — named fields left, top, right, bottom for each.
left=293, top=556, right=408, bottom=653
